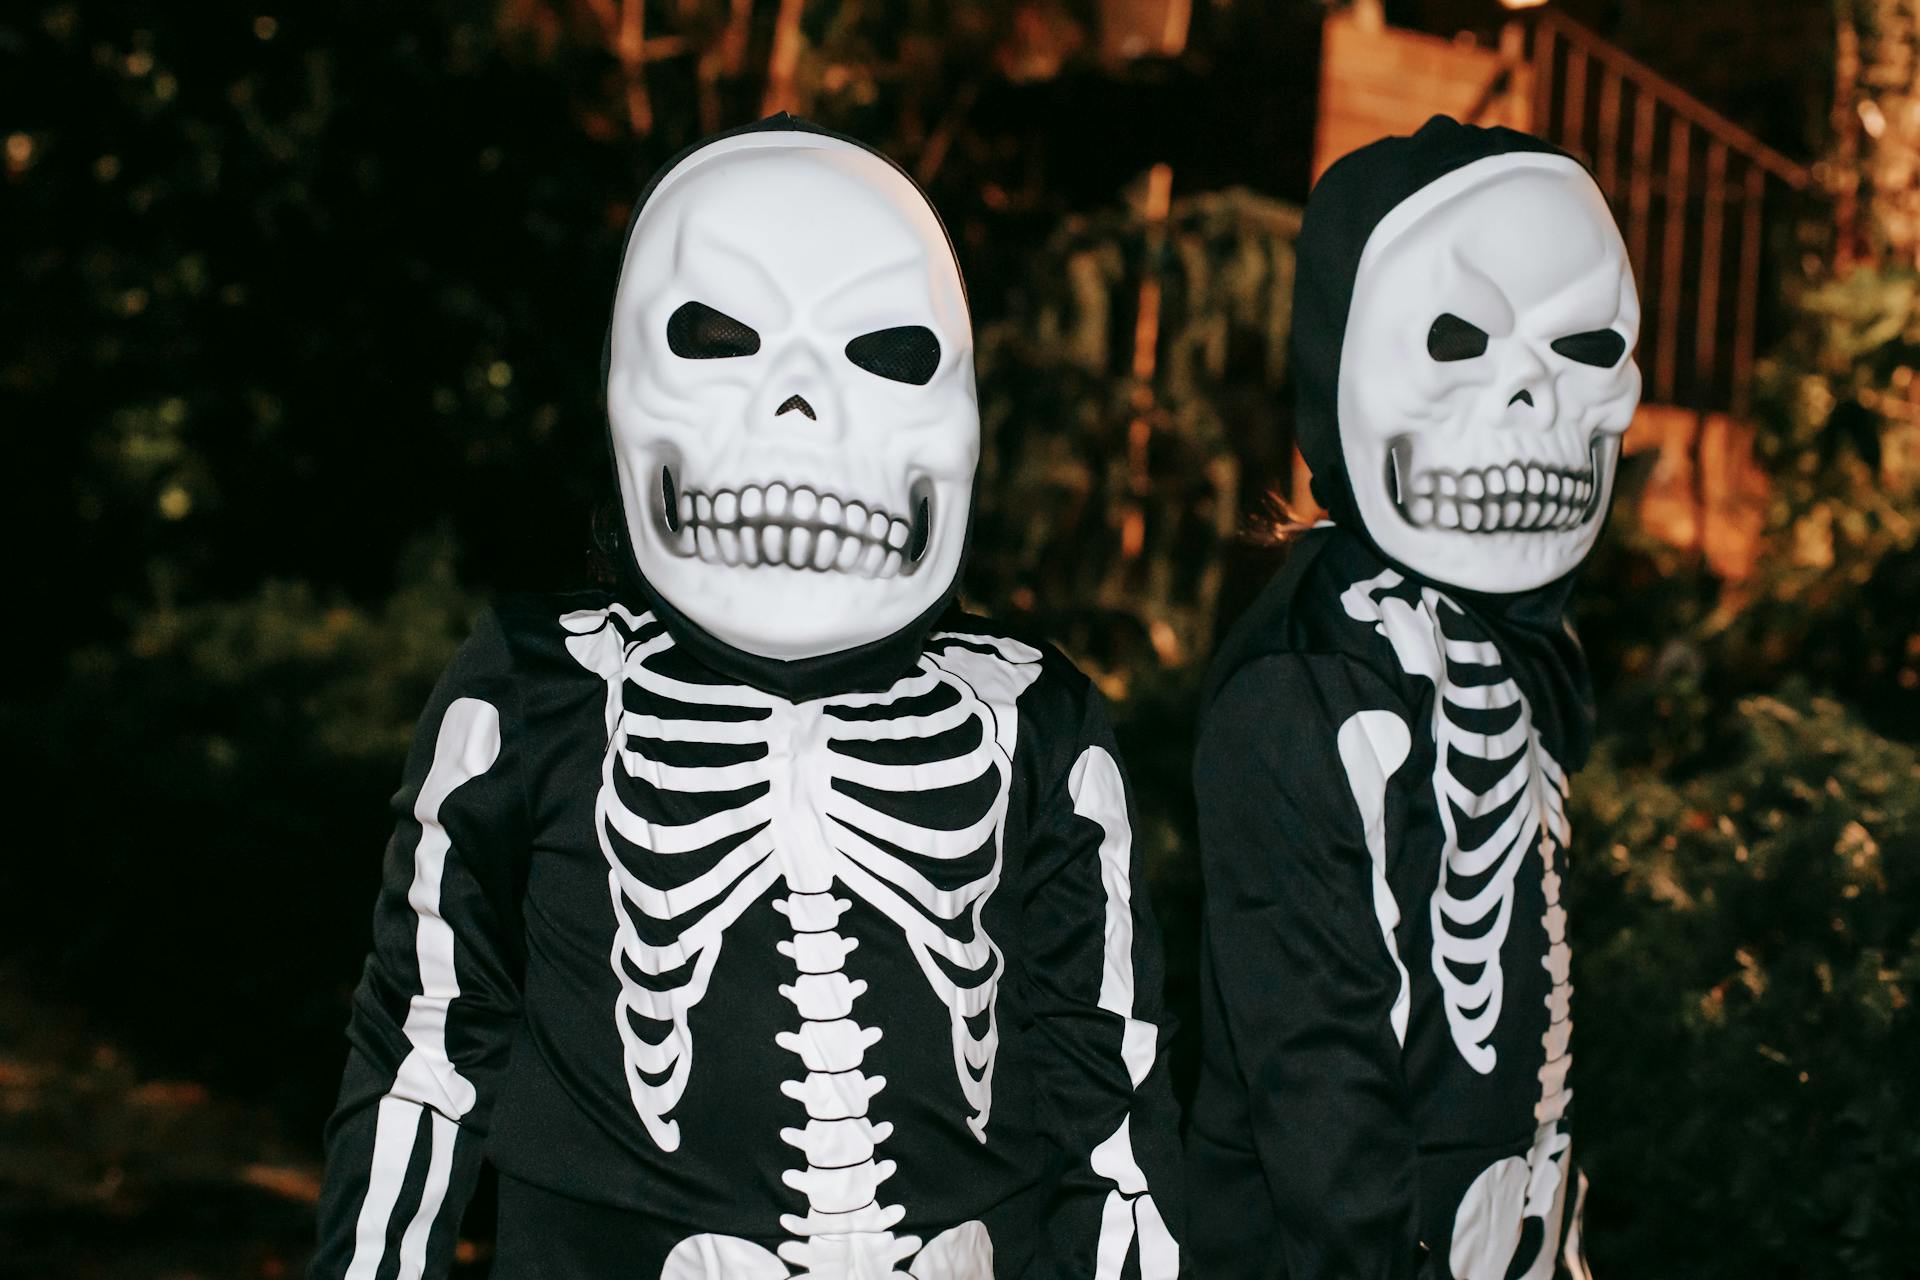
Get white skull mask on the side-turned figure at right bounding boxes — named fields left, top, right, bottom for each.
left=1340, top=154, right=1640, bottom=593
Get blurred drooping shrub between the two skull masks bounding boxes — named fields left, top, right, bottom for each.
left=968, top=190, right=1300, bottom=699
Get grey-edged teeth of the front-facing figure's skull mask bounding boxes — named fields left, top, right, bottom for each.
left=666, top=484, right=920, bottom=578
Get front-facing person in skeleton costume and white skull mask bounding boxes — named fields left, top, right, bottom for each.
left=313, top=117, right=1181, bottom=1280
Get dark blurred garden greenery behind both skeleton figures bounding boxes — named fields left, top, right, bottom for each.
left=0, top=0, right=1920, bottom=1278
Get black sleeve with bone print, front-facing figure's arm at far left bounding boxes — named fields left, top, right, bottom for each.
left=309, top=614, right=528, bottom=1280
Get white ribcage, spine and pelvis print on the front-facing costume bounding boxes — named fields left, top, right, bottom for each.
left=561, top=606, right=1041, bottom=1280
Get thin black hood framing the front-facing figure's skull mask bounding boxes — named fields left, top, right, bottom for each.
left=601, top=111, right=973, bottom=702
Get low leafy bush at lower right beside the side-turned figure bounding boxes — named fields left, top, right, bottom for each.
left=1571, top=689, right=1920, bottom=1278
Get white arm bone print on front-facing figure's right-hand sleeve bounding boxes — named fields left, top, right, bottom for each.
left=1068, top=747, right=1181, bottom=1280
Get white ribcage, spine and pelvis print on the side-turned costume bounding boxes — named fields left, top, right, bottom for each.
left=1340, top=570, right=1572, bottom=1280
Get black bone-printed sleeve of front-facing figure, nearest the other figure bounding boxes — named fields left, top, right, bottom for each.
left=1021, top=685, right=1183, bottom=1280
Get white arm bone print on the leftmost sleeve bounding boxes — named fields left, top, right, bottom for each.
left=348, top=699, right=499, bottom=1280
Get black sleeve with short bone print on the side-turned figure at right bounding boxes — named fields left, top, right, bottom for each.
left=1188, top=654, right=1423, bottom=1280
